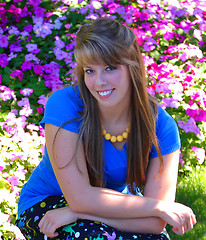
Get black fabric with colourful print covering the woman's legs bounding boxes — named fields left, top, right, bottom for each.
left=16, top=196, right=170, bottom=240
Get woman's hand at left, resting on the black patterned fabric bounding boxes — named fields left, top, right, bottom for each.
left=38, top=207, right=77, bottom=237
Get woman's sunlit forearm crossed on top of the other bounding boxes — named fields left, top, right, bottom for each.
left=69, top=187, right=161, bottom=219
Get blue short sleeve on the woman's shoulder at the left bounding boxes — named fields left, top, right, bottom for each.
left=40, top=86, right=83, bottom=133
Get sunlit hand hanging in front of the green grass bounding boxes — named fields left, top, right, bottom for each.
left=160, top=202, right=197, bottom=235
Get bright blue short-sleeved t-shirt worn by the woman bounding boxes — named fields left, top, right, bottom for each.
left=18, top=86, right=180, bottom=215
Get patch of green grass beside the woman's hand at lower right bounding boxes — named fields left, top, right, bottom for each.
left=167, top=166, right=206, bottom=240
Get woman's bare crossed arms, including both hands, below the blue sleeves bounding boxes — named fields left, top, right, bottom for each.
left=39, top=124, right=196, bottom=237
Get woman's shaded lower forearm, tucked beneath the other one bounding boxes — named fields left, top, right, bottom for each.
left=78, top=214, right=166, bottom=234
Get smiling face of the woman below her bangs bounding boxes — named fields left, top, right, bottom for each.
left=83, top=64, right=131, bottom=108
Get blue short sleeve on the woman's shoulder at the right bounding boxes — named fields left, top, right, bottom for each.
left=149, top=107, right=181, bottom=158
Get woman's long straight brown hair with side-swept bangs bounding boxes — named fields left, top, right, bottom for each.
left=74, top=18, right=163, bottom=193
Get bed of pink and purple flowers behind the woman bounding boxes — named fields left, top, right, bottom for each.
left=0, top=0, right=206, bottom=239
